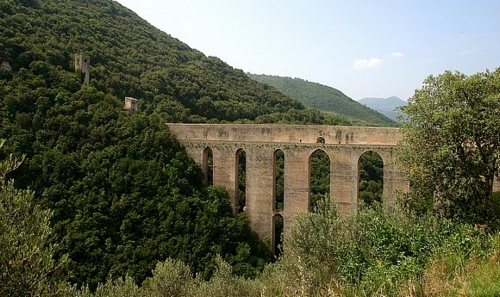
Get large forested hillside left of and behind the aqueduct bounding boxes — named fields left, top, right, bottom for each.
left=0, top=0, right=354, bottom=288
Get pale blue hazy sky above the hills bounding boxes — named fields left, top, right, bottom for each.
left=117, top=0, right=500, bottom=100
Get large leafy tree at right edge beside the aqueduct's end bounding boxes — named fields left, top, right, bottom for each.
left=398, top=68, right=500, bottom=223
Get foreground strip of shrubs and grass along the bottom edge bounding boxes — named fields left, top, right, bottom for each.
left=0, top=153, right=500, bottom=297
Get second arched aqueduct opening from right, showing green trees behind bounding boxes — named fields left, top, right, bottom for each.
left=309, top=150, right=330, bottom=211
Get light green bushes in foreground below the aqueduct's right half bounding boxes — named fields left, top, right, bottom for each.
left=261, top=203, right=492, bottom=296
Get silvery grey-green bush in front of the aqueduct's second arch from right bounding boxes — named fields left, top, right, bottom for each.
left=274, top=199, right=343, bottom=296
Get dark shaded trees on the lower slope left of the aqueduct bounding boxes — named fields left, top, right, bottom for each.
left=0, top=58, right=272, bottom=290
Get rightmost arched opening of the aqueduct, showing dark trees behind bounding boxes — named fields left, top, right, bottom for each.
left=358, top=151, right=384, bottom=206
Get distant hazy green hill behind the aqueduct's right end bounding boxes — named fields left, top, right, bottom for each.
left=248, top=74, right=397, bottom=127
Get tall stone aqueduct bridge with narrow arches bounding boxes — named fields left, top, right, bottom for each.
left=167, top=123, right=408, bottom=244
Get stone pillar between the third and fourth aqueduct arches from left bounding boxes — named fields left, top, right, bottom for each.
left=283, top=150, right=310, bottom=237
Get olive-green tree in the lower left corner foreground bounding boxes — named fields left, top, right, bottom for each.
left=0, top=139, right=64, bottom=296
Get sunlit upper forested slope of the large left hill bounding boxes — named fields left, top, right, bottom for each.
left=0, top=0, right=340, bottom=123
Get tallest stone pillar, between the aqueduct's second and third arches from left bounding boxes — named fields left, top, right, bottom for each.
left=245, top=148, right=274, bottom=242
